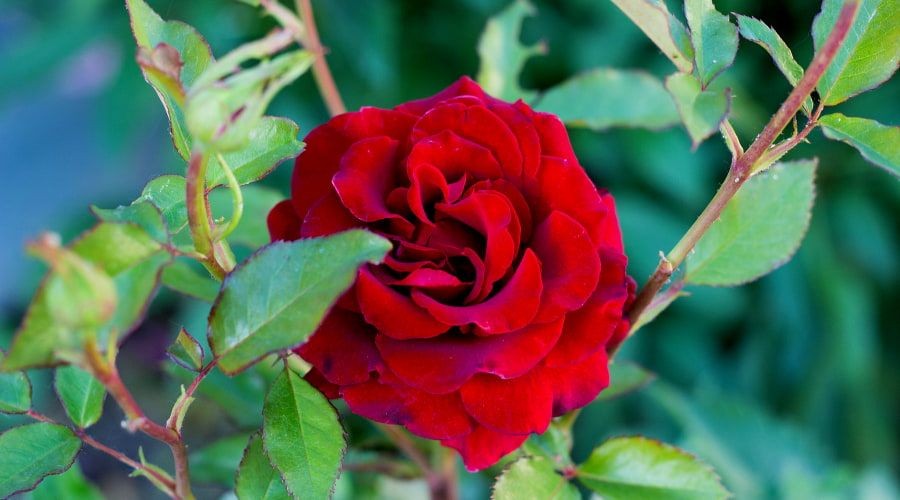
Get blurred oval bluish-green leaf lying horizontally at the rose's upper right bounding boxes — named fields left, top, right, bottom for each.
left=535, top=69, right=680, bottom=130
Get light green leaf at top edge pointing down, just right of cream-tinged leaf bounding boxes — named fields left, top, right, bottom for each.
left=684, top=0, right=738, bottom=89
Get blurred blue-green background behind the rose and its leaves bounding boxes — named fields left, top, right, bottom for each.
left=0, top=0, right=900, bottom=499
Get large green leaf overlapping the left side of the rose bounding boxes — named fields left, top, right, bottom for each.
left=209, top=230, right=391, bottom=373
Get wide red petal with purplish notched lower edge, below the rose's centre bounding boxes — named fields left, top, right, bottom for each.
left=375, top=320, right=563, bottom=394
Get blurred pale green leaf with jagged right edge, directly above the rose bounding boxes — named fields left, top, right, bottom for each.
left=478, top=0, right=546, bottom=101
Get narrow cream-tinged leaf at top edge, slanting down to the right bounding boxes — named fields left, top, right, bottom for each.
left=612, top=0, right=694, bottom=73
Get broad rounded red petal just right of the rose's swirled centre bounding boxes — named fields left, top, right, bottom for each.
left=531, top=210, right=600, bottom=322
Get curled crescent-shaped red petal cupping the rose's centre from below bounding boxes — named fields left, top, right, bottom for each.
left=414, top=249, right=543, bottom=335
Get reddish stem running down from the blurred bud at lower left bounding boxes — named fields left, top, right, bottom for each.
left=85, top=338, right=194, bottom=500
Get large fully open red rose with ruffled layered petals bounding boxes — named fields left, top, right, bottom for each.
left=269, top=78, right=634, bottom=470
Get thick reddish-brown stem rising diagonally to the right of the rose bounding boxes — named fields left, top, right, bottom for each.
left=628, top=1, right=859, bottom=332
